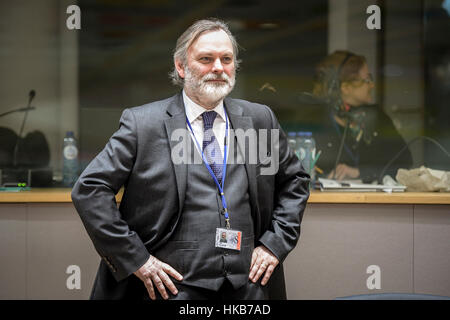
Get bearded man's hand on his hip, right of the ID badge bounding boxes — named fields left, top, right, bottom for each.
left=248, top=246, right=279, bottom=286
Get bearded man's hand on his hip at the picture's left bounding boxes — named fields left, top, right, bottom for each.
left=134, top=256, right=183, bottom=300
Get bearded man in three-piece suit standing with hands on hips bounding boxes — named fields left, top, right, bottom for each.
left=72, top=19, right=309, bottom=300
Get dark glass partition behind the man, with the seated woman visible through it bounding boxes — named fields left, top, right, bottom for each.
left=0, top=0, right=450, bottom=187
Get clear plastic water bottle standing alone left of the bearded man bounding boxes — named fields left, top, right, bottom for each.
left=62, top=131, right=78, bottom=187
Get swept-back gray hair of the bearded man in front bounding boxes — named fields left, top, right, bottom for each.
left=169, top=18, right=240, bottom=87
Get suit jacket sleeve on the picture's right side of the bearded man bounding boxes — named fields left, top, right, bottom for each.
left=259, top=108, right=310, bottom=263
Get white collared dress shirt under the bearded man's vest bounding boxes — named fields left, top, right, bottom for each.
left=183, top=90, right=231, bottom=158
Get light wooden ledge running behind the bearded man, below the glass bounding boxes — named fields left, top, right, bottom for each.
left=0, top=189, right=450, bottom=204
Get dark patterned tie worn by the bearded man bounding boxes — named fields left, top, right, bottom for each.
left=202, top=111, right=223, bottom=183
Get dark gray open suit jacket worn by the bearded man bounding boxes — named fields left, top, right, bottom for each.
left=72, top=93, right=309, bottom=298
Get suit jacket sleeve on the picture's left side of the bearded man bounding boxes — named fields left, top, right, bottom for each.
left=72, top=109, right=150, bottom=281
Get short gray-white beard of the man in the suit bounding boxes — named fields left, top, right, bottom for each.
left=184, top=66, right=236, bottom=108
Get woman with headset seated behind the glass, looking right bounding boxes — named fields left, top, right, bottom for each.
left=313, top=51, right=412, bottom=183
